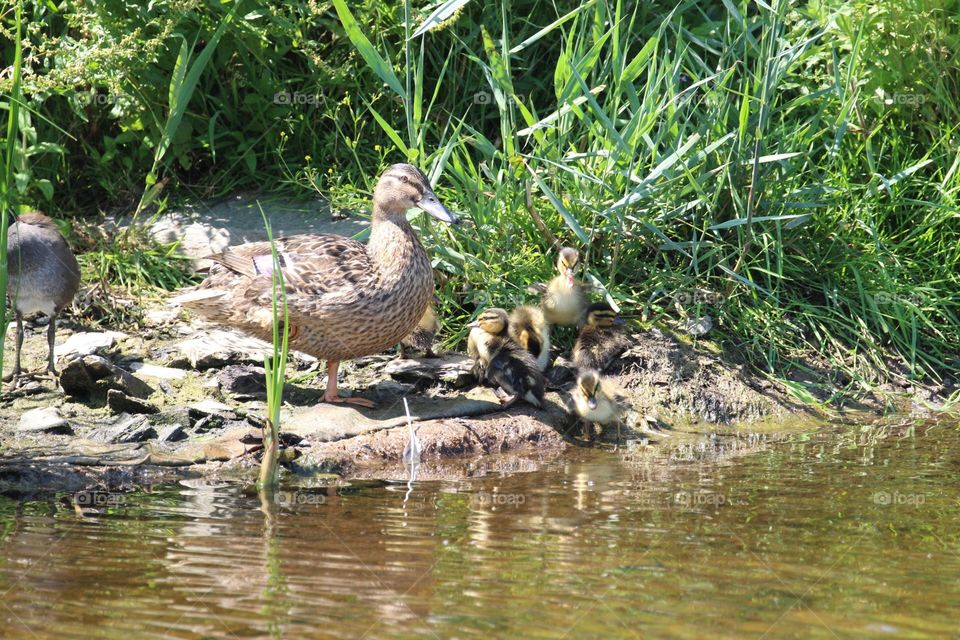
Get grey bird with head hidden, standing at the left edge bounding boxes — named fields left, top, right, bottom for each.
left=7, top=211, right=80, bottom=386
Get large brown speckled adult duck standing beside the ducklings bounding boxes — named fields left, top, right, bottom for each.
left=174, top=164, right=458, bottom=407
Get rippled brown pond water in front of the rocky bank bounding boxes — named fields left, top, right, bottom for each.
left=0, top=423, right=960, bottom=640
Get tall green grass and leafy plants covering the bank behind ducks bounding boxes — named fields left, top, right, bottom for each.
left=0, top=0, right=960, bottom=394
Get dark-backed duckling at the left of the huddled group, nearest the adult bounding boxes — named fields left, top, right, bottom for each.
left=467, top=308, right=544, bottom=407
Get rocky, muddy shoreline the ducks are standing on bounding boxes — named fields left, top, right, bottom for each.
left=0, top=200, right=951, bottom=493
